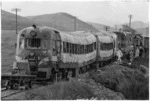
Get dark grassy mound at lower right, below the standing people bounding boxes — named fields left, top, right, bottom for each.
left=91, top=65, right=149, bottom=100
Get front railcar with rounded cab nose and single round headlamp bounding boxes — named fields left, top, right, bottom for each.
left=13, top=26, right=96, bottom=80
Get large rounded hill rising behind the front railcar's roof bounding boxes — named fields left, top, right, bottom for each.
left=27, top=12, right=98, bottom=32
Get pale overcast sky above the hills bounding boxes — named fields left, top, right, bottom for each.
left=2, top=0, right=149, bottom=26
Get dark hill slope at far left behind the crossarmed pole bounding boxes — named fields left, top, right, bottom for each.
left=1, top=10, right=33, bottom=30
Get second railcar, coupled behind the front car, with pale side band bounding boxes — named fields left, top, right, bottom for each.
left=94, top=31, right=116, bottom=66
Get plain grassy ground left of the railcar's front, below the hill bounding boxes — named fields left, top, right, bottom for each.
left=1, top=30, right=17, bottom=73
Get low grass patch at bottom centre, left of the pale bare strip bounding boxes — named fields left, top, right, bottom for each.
left=26, top=80, right=95, bottom=100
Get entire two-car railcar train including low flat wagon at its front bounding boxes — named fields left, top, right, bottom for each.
left=2, top=26, right=122, bottom=88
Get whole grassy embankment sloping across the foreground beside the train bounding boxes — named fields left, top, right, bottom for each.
left=2, top=59, right=149, bottom=100
